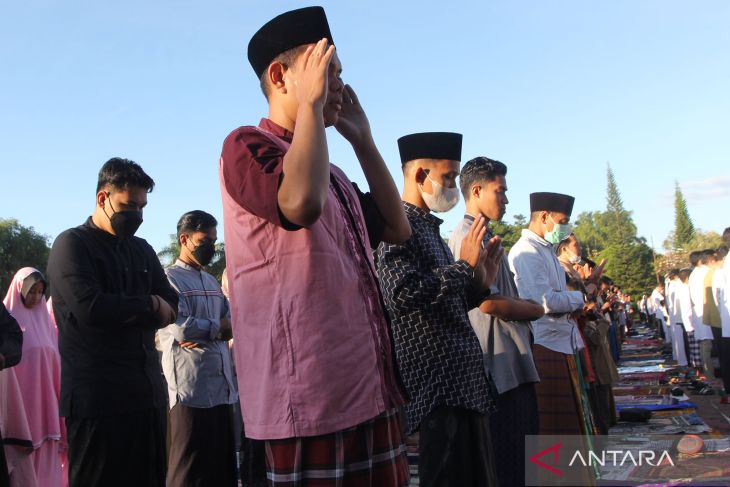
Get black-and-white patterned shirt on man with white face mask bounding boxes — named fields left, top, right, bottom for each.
left=376, top=203, right=493, bottom=434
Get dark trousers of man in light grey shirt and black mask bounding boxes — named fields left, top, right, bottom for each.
left=167, top=403, right=238, bottom=487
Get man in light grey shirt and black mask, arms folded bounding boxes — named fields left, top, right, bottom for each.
left=159, top=210, right=238, bottom=487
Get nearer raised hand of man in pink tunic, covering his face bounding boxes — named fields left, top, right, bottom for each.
left=295, top=39, right=335, bottom=108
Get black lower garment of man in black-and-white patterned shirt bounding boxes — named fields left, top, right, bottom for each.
left=418, top=406, right=497, bottom=487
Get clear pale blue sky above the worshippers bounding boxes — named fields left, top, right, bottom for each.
left=0, top=0, right=730, bottom=255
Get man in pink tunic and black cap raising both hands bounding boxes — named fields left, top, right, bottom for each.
left=220, top=7, right=410, bottom=487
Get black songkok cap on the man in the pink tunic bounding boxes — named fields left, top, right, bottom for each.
left=248, top=7, right=334, bottom=78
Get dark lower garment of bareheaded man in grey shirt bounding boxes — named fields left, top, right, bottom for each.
left=489, top=384, right=540, bottom=487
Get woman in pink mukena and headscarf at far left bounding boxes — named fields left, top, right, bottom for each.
left=0, top=267, right=68, bottom=487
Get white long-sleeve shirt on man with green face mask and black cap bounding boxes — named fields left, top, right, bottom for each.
left=507, top=229, right=584, bottom=354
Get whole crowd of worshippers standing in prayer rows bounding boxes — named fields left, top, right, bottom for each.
left=0, top=7, right=730, bottom=487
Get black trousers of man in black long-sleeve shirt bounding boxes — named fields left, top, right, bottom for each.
left=66, top=409, right=167, bottom=487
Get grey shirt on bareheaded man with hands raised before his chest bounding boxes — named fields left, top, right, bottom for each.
left=449, top=215, right=540, bottom=394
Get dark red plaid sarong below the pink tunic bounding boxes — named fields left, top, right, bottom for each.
left=266, top=410, right=409, bottom=487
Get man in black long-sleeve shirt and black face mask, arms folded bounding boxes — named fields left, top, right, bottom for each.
left=47, top=158, right=178, bottom=487
